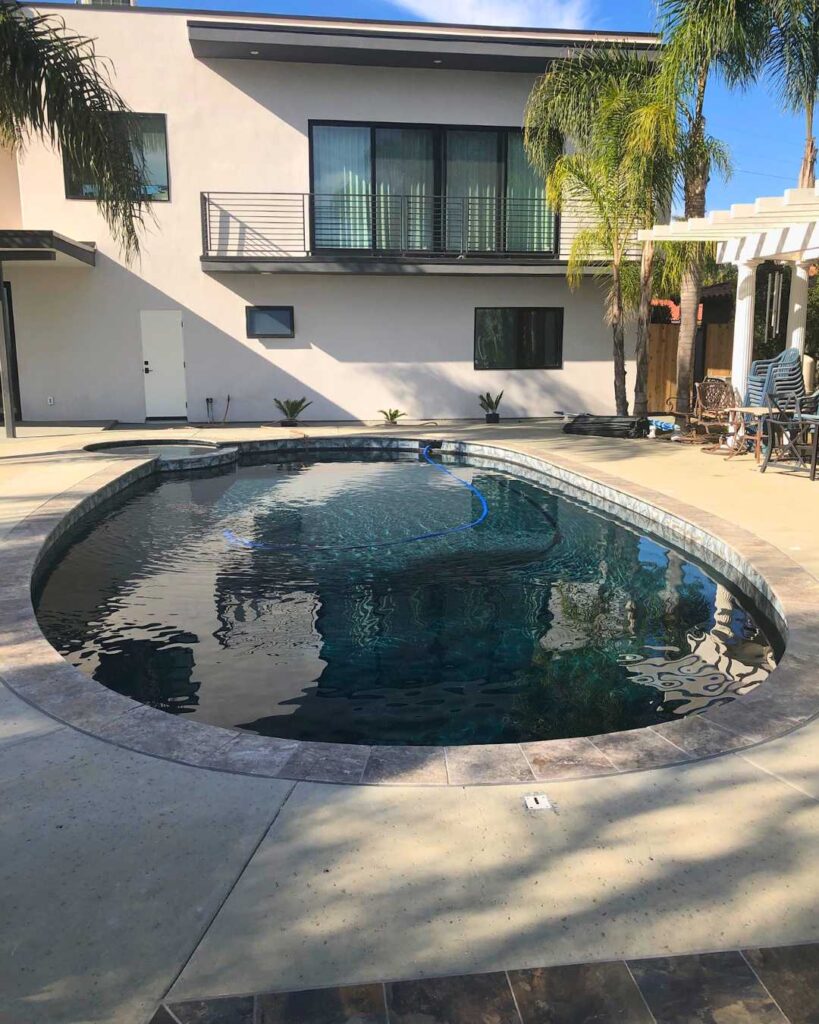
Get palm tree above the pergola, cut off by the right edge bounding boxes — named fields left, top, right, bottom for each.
left=767, top=0, right=819, bottom=188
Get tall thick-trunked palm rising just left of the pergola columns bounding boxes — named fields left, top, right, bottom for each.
left=658, top=0, right=771, bottom=418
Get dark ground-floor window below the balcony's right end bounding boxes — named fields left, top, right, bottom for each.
left=475, top=306, right=563, bottom=370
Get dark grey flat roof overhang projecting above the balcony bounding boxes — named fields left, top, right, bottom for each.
left=187, top=18, right=658, bottom=74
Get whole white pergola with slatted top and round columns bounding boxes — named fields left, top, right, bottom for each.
left=639, top=186, right=819, bottom=393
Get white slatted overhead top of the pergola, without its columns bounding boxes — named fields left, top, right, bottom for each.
left=639, top=187, right=819, bottom=263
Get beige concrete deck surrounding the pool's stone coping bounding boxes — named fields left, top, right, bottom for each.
left=0, top=424, right=819, bottom=1024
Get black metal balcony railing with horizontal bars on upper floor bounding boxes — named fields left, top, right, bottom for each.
left=202, top=193, right=557, bottom=259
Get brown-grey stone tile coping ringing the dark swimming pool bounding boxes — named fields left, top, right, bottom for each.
left=0, top=435, right=819, bottom=785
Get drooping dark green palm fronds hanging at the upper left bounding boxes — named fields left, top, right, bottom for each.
left=0, top=0, right=147, bottom=258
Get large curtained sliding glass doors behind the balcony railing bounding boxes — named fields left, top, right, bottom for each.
left=310, top=124, right=556, bottom=256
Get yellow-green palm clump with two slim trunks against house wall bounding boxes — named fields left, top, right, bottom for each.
left=525, top=47, right=675, bottom=416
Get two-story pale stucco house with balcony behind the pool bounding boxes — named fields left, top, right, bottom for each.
left=0, top=4, right=654, bottom=422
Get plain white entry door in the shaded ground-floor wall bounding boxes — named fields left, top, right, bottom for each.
left=139, top=309, right=187, bottom=420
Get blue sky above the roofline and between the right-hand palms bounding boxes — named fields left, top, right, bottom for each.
left=105, top=0, right=803, bottom=209
